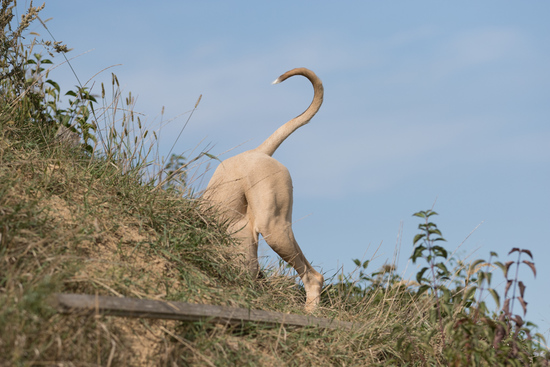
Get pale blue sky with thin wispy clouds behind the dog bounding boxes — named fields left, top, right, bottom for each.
left=19, top=0, right=550, bottom=337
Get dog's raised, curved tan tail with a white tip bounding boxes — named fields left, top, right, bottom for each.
left=254, top=68, right=324, bottom=156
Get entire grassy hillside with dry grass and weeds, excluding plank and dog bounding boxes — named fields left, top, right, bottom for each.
left=0, top=0, right=549, bottom=366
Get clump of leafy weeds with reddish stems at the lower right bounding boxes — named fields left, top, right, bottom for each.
left=390, top=210, right=548, bottom=366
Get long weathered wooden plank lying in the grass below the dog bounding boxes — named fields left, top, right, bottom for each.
left=54, top=294, right=359, bottom=330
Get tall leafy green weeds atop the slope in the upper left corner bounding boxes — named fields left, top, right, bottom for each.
left=0, top=0, right=96, bottom=153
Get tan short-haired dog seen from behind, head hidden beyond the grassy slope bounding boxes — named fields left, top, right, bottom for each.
left=204, top=68, right=324, bottom=311
